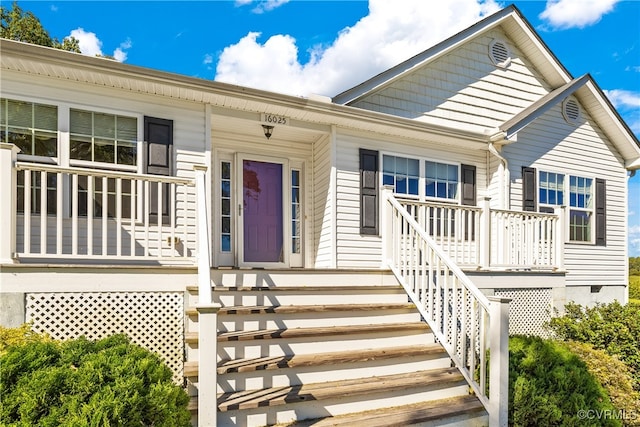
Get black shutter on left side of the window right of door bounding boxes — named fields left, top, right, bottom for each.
left=360, top=148, right=379, bottom=235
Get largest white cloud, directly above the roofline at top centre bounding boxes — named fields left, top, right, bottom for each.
left=215, top=0, right=501, bottom=96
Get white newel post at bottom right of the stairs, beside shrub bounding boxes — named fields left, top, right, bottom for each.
left=488, top=297, right=511, bottom=427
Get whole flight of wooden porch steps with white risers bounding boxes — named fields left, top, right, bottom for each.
left=184, top=272, right=487, bottom=427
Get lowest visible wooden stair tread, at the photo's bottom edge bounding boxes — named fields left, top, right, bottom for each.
left=277, top=396, right=485, bottom=427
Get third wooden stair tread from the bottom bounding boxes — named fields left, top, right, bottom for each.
left=184, top=344, right=446, bottom=377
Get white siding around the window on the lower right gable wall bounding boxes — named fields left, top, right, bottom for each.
left=503, top=104, right=627, bottom=292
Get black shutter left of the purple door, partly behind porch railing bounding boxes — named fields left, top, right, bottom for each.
left=144, top=117, right=173, bottom=224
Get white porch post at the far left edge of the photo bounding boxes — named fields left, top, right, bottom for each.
left=0, top=142, right=20, bottom=264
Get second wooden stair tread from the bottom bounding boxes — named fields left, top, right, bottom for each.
left=218, top=368, right=464, bottom=412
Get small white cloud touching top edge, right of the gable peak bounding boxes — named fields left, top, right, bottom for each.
left=540, top=0, right=619, bottom=29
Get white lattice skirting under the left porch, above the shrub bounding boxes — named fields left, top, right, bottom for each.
left=26, top=292, right=184, bottom=383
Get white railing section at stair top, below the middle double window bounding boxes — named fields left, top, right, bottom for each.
left=400, top=200, right=482, bottom=266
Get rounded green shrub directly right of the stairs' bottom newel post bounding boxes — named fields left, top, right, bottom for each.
left=509, top=336, right=621, bottom=427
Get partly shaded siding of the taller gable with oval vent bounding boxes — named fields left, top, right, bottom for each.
left=353, top=28, right=551, bottom=132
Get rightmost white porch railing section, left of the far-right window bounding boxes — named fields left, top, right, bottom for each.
left=490, top=209, right=563, bottom=268
